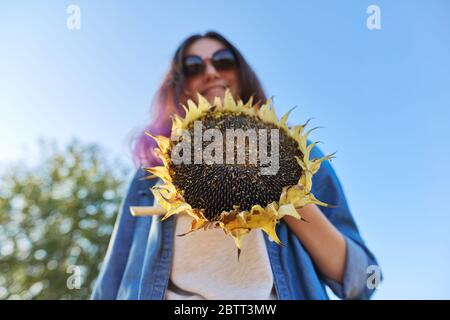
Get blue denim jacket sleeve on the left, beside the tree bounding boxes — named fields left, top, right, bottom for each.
left=91, top=169, right=155, bottom=300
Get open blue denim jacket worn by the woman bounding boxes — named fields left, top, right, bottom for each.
left=91, top=147, right=378, bottom=300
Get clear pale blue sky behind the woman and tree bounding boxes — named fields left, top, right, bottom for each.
left=0, top=0, right=450, bottom=299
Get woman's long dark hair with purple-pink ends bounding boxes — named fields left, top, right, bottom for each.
left=132, top=31, right=266, bottom=167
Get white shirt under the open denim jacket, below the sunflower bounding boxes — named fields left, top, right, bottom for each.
left=165, top=214, right=277, bottom=300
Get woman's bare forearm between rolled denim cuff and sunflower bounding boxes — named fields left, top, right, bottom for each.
left=283, top=204, right=346, bottom=283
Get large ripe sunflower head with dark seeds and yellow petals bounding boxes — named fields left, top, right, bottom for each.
left=145, top=90, right=333, bottom=256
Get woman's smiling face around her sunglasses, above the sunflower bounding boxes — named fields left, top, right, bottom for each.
left=184, top=38, right=240, bottom=104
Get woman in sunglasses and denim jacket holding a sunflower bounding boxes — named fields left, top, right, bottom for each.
left=92, top=32, right=377, bottom=299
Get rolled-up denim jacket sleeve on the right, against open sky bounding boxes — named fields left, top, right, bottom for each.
left=311, top=147, right=382, bottom=299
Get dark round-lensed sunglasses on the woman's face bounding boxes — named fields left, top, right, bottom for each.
left=183, top=48, right=236, bottom=77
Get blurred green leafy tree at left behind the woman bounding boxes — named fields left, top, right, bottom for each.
left=0, top=141, right=129, bottom=299
